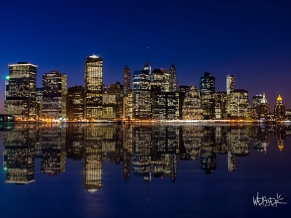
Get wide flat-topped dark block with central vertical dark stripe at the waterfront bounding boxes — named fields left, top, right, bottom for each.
left=152, top=92, right=180, bottom=120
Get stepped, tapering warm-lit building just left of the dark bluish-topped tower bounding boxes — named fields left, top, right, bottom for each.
left=182, top=86, right=203, bottom=120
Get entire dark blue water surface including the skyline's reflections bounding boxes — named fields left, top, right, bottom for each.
left=0, top=124, right=291, bottom=217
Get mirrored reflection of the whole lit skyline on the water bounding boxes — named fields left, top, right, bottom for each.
left=1, top=123, right=291, bottom=188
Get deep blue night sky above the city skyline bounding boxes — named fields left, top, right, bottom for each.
left=0, top=0, right=291, bottom=113
